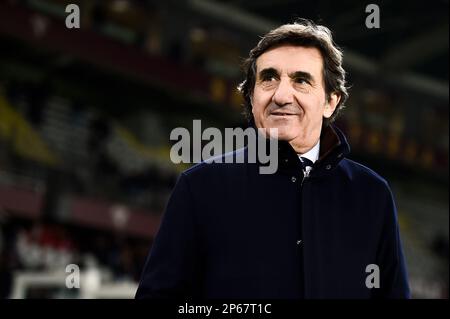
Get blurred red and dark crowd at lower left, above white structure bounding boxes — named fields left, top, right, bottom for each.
left=0, top=214, right=151, bottom=298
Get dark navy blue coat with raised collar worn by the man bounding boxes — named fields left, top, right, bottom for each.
left=136, top=126, right=409, bottom=299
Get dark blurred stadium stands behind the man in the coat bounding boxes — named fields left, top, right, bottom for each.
left=0, top=0, right=449, bottom=298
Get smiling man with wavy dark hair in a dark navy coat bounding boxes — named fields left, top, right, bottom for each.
left=136, top=20, right=409, bottom=299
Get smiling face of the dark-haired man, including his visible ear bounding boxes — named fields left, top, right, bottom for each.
left=251, top=45, right=339, bottom=153
